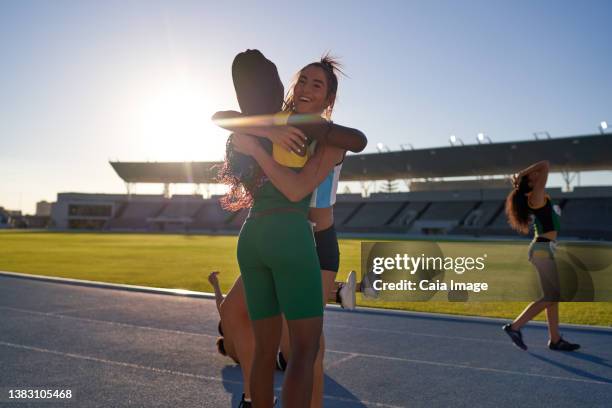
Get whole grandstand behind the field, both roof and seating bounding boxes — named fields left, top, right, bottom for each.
left=88, top=134, right=612, bottom=239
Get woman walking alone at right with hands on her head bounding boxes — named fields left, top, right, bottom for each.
left=503, top=161, right=580, bottom=351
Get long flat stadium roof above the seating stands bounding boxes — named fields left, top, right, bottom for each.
left=110, top=134, right=612, bottom=184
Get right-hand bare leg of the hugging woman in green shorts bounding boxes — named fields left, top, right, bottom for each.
left=286, top=317, right=323, bottom=408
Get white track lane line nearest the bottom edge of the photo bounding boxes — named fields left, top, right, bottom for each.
left=0, top=341, right=402, bottom=408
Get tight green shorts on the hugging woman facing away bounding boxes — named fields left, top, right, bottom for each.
left=238, top=212, right=323, bottom=320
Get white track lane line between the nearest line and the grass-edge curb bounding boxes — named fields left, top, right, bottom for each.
left=0, top=306, right=612, bottom=385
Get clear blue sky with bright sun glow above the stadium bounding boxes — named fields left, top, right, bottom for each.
left=0, top=0, right=612, bottom=212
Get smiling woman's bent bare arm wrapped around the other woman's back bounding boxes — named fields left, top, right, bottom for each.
left=232, top=134, right=344, bottom=202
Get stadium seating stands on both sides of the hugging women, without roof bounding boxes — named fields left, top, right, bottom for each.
left=51, top=187, right=612, bottom=240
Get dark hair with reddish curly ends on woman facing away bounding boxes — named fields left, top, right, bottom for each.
left=217, top=50, right=284, bottom=211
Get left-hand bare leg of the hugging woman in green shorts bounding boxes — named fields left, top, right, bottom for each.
left=250, top=315, right=284, bottom=408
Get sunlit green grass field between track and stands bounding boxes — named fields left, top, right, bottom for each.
left=0, top=231, right=612, bottom=326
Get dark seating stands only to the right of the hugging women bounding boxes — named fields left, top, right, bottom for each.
left=334, top=187, right=612, bottom=240
